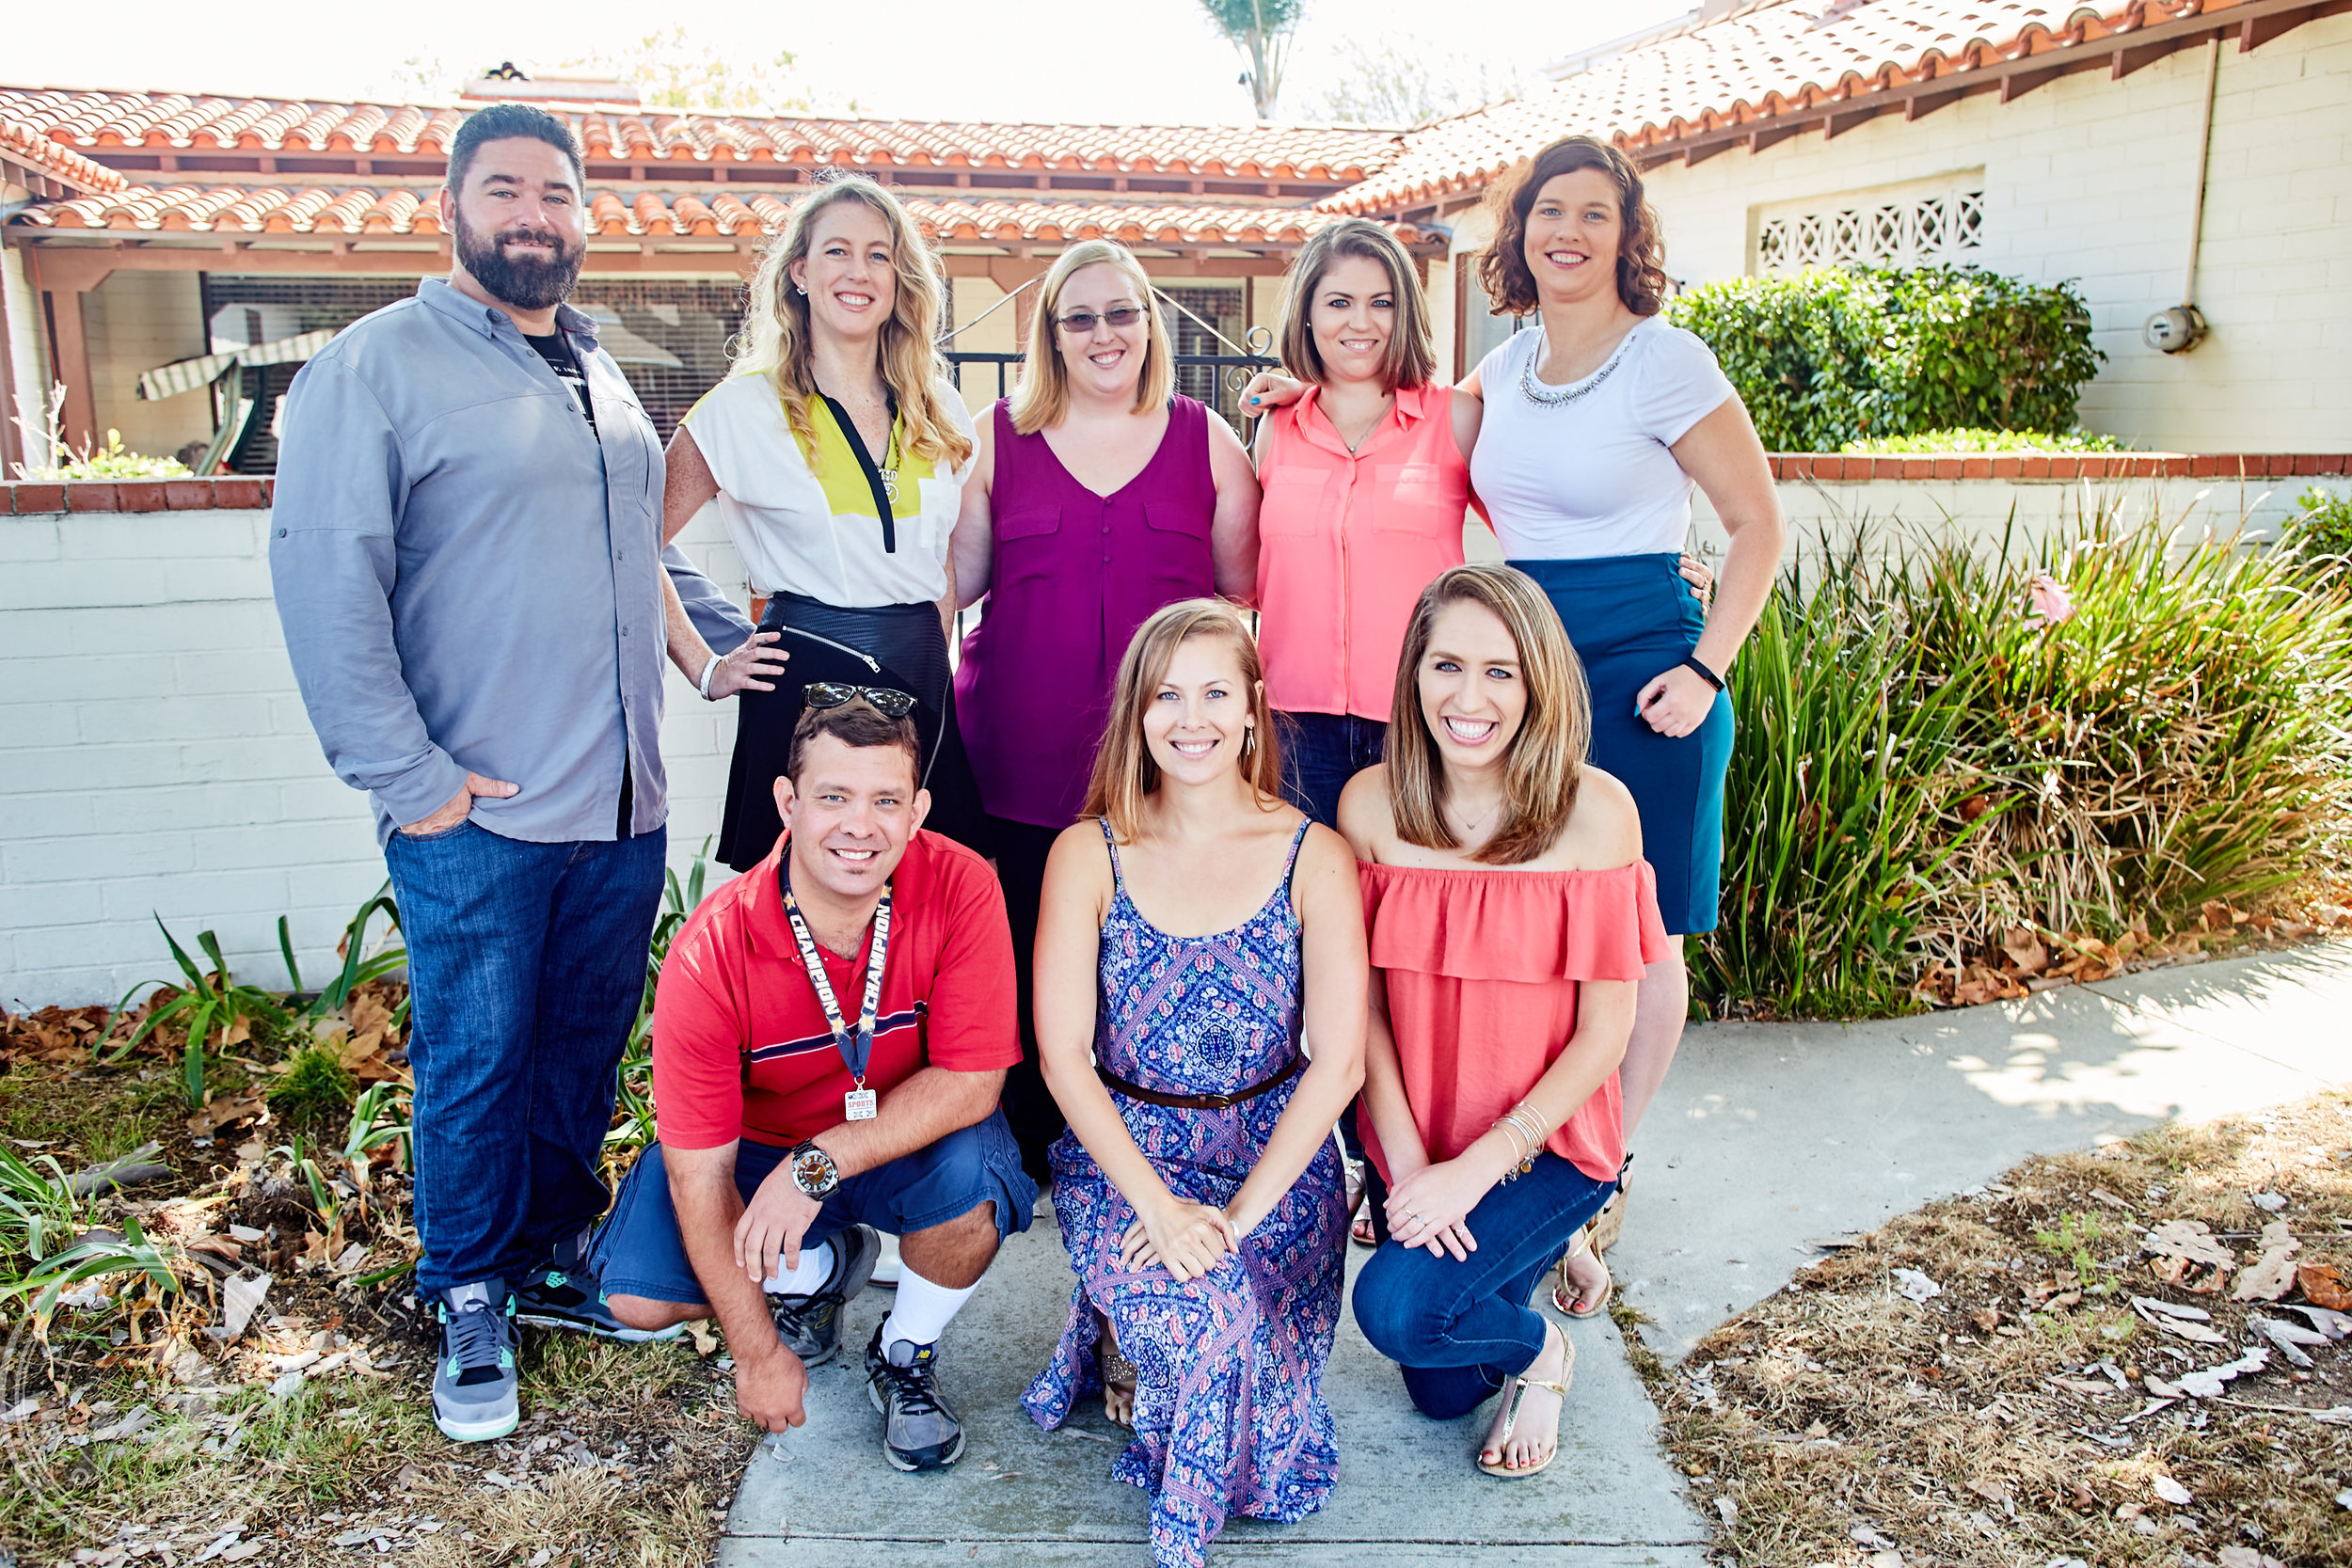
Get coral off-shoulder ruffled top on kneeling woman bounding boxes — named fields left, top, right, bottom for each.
left=1358, top=861, right=1673, bottom=1180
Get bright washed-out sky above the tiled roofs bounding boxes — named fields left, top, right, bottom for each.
left=0, top=0, right=1692, bottom=124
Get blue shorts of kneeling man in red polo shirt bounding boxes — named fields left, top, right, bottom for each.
left=588, top=1110, right=1038, bottom=1305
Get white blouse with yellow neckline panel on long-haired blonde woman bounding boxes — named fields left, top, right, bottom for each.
left=682, top=376, right=974, bottom=609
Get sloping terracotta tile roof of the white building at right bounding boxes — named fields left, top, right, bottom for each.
left=1320, top=0, right=2286, bottom=212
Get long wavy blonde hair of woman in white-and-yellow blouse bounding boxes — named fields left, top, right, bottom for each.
left=729, top=174, right=972, bottom=467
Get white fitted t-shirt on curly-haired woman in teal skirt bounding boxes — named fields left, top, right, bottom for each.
left=1470, top=315, right=1734, bottom=560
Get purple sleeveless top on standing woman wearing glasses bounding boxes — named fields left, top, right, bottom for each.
left=955, top=397, right=1216, bottom=828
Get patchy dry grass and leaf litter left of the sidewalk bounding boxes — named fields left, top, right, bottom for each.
left=0, top=1016, right=755, bottom=1568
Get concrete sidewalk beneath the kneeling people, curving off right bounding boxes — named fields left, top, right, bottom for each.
left=718, top=945, right=2352, bottom=1568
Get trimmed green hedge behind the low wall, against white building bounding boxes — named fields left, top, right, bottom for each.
left=1665, top=268, right=2106, bottom=451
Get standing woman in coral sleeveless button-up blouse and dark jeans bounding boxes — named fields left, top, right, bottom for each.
left=1256, top=218, right=1480, bottom=825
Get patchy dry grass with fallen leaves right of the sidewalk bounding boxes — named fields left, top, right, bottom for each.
left=1642, top=1093, right=2352, bottom=1568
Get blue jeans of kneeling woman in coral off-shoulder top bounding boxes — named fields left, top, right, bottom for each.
left=1355, top=1154, right=1616, bottom=1420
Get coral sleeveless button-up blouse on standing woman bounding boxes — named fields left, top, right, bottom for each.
left=1259, top=386, right=1470, bottom=721
